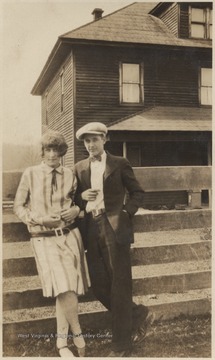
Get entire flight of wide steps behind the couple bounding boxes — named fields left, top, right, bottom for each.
left=3, top=209, right=211, bottom=343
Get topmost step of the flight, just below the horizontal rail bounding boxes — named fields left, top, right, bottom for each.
left=3, top=209, right=212, bottom=242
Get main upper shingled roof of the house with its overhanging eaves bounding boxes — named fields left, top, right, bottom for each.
left=31, top=2, right=212, bottom=95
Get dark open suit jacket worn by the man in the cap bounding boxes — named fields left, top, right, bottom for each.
left=74, top=154, right=144, bottom=244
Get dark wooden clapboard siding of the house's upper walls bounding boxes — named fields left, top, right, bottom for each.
left=39, top=45, right=212, bottom=166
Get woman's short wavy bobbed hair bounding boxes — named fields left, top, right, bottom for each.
left=41, top=130, right=68, bottom=156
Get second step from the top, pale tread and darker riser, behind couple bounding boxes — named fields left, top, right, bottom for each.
left=3, top=228, right=211, bottom=277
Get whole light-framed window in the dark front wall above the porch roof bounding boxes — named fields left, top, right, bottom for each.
left=120, top=63, right=144, bottom=103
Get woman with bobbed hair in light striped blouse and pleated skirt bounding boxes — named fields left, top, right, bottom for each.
left=14, top=131, right=90, bottom=357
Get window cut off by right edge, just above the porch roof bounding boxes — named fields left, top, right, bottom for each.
left=200, top=68, right=212, bottom=105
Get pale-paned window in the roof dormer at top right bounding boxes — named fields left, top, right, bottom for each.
left=190, top=7, right=213, bottom=39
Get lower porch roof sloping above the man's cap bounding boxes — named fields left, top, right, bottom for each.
left=108, top=106, right=212, bottom=131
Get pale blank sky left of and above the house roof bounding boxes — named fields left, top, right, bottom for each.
left=0, top=0, right=139, bottom=144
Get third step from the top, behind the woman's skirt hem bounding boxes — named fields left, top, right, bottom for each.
left=3, top=260, right=211, bottom=310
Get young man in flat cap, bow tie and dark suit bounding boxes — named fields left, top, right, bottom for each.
left=75, top=122, right=154, bottom=357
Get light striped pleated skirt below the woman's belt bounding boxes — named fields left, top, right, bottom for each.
left=31, top=228, right=90, bottom=297
